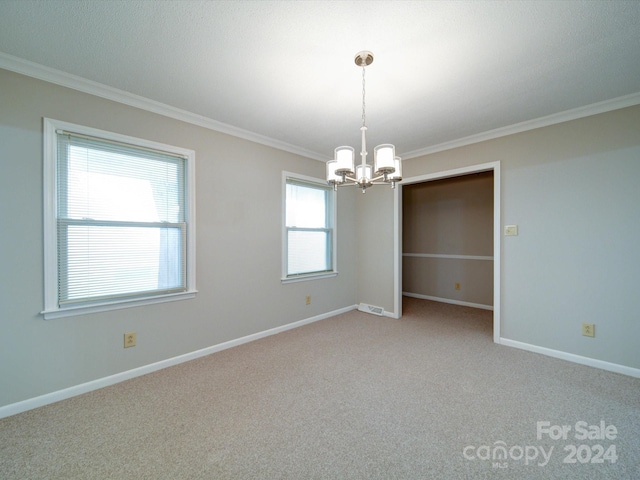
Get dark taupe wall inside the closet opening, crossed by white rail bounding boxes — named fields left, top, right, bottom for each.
left=402, top=172, right=493, bottom=307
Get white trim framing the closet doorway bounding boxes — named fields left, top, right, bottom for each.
left=393, top=161, right=502, bottom=343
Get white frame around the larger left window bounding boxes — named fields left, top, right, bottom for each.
left=41, top=118, right=197, bottom=320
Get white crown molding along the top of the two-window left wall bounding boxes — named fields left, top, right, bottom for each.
left=0, top=52, right=327, bottom=161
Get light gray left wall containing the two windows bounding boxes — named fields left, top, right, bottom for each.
left=0, top=69, right=357, bottom=406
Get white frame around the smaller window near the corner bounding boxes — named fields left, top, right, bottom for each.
left=281, top=171, right=338, bottom=283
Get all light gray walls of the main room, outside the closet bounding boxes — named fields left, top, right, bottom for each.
left=0, top=65, right=640, bottom=406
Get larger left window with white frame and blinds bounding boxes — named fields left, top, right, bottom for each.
left=43, top=119, right=195, bottom=318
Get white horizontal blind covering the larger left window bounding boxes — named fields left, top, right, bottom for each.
left=56, top=131, right=187, bottom=306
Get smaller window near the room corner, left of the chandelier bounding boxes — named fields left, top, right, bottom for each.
left=283, top=173, right=336, bottom=281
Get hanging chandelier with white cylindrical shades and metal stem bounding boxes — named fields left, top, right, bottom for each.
left=327, top=50, right=402, bottom=193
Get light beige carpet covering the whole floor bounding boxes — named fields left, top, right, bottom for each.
left=0, top=298, right=640, bottom=480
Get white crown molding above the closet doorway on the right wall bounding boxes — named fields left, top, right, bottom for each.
left=402, top=92, right=640, bottom=160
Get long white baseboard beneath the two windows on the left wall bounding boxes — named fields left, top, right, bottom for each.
left=0, top=305, right=357, bottom=418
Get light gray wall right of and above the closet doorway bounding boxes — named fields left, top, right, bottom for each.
left=398, top=106, right=640, bottom=368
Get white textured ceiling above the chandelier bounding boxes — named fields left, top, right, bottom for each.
left=0, top=0, right=640, bottom=160
